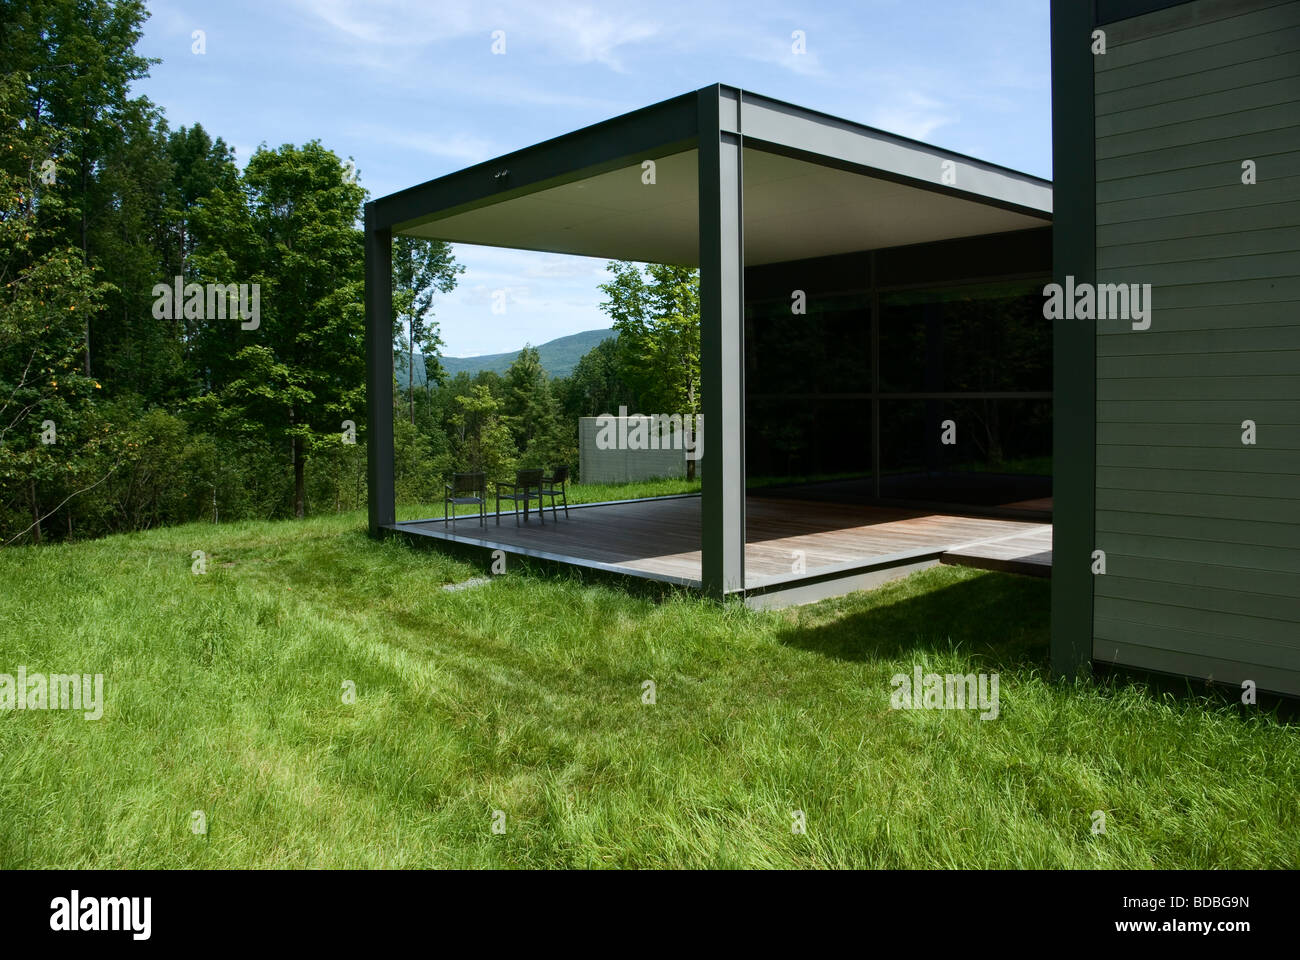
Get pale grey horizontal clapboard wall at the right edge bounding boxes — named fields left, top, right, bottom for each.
left=1093, top=0, right=1300, bottom=695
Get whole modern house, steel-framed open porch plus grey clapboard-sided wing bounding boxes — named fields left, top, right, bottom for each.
left=365, top=0, right=1300, bottom=693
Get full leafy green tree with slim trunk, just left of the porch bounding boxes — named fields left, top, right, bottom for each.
left=195, top=140, right=365, bottom=516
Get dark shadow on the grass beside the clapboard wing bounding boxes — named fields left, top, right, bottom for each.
left=779, top=571, right=1052, bottom=670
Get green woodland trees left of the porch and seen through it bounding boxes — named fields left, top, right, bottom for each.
left=0, top=0, right=698, bottom=544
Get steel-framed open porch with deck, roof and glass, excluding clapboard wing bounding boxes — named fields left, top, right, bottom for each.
left=365, top=86, right=1052, bottom=606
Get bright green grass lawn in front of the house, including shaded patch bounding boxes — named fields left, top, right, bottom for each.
left=0, top=504, right=1300, bottom=868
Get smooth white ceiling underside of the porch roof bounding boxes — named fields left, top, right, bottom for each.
left=402, top=141, right=1050, bottom=265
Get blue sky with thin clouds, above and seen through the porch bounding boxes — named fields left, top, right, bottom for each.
left=137, top=0, right=1052, bottom=356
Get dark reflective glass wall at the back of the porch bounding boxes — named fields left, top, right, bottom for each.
left=745, top=230, right=1052, bottom=514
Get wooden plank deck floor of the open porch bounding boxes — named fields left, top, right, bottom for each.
left=393, top=497, right=1052, bottom=591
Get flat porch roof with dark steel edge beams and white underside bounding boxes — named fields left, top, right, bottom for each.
left=368, top=87, right=1052, bottom=265
